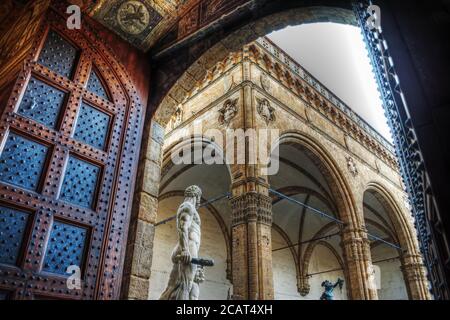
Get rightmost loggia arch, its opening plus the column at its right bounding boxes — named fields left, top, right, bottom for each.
left=363, top=183, right=428, bottom=300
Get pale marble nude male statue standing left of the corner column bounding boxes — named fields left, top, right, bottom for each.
left=160, top=185, right=204, bottom=300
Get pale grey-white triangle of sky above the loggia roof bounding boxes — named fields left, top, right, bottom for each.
left=268, top=23, right=391, bottom=141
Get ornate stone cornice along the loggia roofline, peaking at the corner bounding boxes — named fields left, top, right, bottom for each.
left=168, top=40, right=398, bottom=170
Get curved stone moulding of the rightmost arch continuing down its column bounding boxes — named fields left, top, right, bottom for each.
left=364, top=182, right=430, bottom=300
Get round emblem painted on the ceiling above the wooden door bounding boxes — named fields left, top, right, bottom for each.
left=117, top=0, right=150, bottom=34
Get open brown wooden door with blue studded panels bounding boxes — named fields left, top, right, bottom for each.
left=0, top=5, right=143, bottom=299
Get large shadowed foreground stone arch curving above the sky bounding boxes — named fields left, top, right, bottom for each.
left=150, top=1, right=357, bottom=126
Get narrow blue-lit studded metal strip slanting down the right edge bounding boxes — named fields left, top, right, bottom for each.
left=353, top=1, right=447, bottom=299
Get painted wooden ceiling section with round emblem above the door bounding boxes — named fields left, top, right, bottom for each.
left=70, top=0, right=253, bottom=51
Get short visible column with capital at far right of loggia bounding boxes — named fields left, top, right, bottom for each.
left=401, top=253, right=431, bottom=300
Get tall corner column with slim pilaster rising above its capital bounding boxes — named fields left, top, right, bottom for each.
left=227, top=55, right=274, bottom=300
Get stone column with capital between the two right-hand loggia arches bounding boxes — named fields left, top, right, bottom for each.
left=341, top=227, right=378, bottom=300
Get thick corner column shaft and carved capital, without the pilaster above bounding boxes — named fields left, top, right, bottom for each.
left=231, top=186, right=274, bottom=300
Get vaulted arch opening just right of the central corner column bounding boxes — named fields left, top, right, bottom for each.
left=269, top=134, right=351, bottom=300
